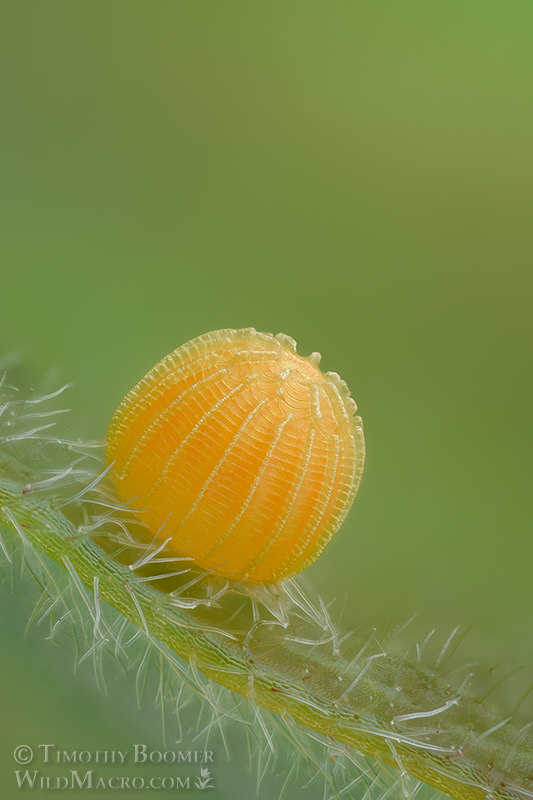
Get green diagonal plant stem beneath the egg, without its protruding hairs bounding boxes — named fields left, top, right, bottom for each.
left=0, top=488, right=533, bottom=800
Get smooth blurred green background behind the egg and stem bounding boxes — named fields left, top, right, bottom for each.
left=0, top=0, right=533, bottom=797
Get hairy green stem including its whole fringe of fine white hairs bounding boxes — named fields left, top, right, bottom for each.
left=0, top=380, right=533, bottom=800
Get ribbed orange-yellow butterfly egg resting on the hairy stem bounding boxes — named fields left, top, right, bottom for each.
left=107, top=328, right=365, bottom=583
